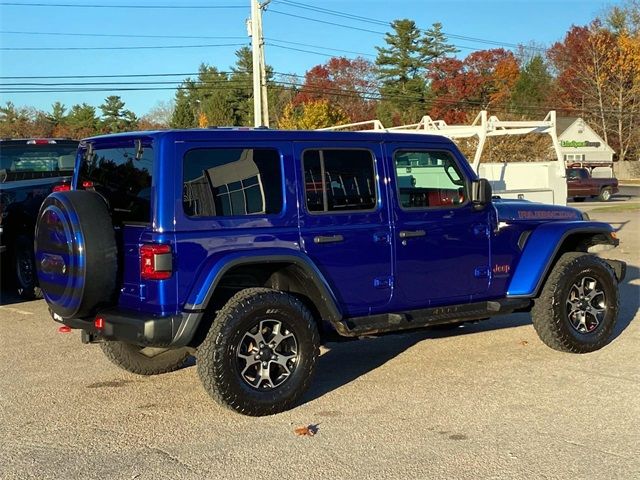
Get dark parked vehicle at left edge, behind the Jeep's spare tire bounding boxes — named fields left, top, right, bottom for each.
left=0, top=138, right=79, bottom=298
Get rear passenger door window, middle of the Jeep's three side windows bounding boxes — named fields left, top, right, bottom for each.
left=302, top=150, right=376, bottom=213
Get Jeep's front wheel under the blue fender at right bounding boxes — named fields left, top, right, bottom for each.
left=531, top=252, right=619, bottom=353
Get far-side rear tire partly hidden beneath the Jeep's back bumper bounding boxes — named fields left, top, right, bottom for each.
left=100, top=341, right=191, bottom=375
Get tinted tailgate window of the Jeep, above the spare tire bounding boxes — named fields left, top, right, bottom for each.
left=77, top=142, right=153, bottom=225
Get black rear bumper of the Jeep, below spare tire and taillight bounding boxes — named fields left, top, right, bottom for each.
left=52, top=309, right=202, bottom=347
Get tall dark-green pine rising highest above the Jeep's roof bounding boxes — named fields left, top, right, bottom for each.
left=376, top=19, right=456, bottom=123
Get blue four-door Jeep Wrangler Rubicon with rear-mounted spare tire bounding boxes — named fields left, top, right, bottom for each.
left=36, top=129, right=625, bottom=415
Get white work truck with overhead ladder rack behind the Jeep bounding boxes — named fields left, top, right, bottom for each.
left=321, top=110, right=567, bottom=205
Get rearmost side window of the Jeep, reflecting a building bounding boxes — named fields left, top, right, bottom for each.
left=182, top=148, right=282, bottom=217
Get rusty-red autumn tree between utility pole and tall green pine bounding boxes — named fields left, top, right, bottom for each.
left=293, top=57, right=377, bottom=122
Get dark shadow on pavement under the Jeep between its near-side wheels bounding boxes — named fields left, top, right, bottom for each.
left=301, top=313, right=531, bottom=404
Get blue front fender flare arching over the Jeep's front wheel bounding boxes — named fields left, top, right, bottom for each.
left=507, top=221, right=618, bottom=298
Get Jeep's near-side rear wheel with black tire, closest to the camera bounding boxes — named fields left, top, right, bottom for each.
left=197, top=288, right=320, bottom=416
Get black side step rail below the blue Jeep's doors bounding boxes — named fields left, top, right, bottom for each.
left=337, top=298, right=531, bottom=337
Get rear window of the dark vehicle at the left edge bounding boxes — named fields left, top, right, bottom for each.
left=0, top=142, right=78, bottom=177
